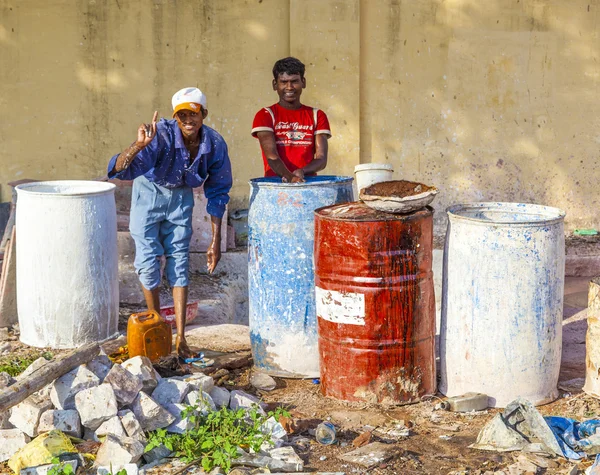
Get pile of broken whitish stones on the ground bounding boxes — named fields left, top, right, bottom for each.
left=0, top=354, right=303, bottom=475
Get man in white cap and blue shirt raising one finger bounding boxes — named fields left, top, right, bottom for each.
left=108, top=87, right=232, bottom=358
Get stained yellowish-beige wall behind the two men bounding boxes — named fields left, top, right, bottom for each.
left=0, top=0, right=600, bottom=230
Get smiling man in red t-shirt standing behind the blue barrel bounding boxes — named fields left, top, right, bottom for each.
left=252, top=58, right=331, bottom=183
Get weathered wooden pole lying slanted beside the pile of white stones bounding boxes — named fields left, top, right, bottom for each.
left=0, top=343, right=100, bottom=413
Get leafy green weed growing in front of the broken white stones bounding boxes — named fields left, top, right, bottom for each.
left=146, top=406, right=289, bottom=472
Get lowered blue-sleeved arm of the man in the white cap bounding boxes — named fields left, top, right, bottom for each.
left=204, top=138, right=233, bottom=274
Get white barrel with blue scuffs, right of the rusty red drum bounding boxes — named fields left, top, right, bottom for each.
left=440, top=203, right=565, bottom=407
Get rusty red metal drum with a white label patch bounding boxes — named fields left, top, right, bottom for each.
left=314, top=202, right=436, bottom=404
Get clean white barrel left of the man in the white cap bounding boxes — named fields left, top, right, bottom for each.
left=16, top=181, right=119, bottom=348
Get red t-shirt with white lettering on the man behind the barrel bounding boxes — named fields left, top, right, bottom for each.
left=252, top=104, right=331, bottom=176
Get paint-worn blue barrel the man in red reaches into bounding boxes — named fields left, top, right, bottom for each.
left=248, top=176, right=352, bottom=378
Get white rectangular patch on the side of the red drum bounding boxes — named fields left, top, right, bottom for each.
left=315, top=287, right=365, bottom=325
